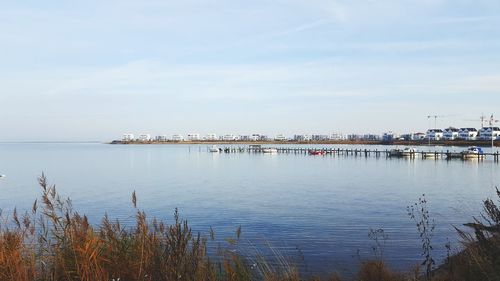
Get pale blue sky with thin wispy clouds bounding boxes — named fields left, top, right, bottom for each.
left=0, top=0, right=500, bottom=141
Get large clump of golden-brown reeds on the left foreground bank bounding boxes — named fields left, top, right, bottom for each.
left=0, top=175, right=306, bottom=281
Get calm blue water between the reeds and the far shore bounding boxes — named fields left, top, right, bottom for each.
left=0, top=143, right=500, bottom=274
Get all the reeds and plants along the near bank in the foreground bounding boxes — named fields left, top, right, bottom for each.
left=0, top=175, right=500, bottom=281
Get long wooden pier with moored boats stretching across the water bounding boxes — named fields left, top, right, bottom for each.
left=207, top=145, right=500, bottom=163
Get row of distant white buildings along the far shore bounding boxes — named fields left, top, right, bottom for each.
left=114, top=126, right=500, bottom=143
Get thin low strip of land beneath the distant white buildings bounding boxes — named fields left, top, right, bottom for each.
left=109, top=140, right=500, bottom=147
